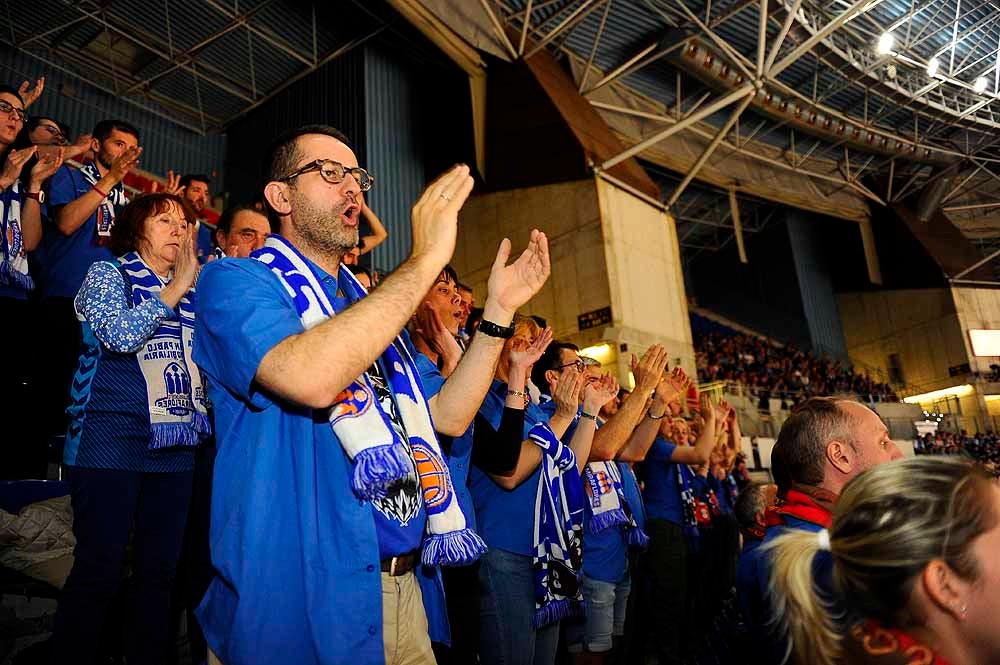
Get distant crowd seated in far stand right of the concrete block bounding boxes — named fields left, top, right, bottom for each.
left=694, top=331, right=899, bottom=406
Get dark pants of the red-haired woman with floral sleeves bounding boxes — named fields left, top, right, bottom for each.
left=52, top=467, right=192, bottom=665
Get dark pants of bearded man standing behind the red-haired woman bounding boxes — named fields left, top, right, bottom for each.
left=41, top=298, right=83, bottom=434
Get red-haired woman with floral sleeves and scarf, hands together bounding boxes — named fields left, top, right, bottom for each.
left=53, top=193, right=210, bottom=663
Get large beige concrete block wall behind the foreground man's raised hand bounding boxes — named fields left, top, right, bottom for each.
left=452, top=180, right=695, bottom=386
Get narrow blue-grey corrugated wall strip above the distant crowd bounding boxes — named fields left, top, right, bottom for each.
left=787, top=209, right=848, bottom=360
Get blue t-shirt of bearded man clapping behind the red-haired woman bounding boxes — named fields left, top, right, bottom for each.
left=39, top=164, right=124, bottom=298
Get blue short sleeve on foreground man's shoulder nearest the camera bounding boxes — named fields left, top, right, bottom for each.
left=194, top=259, right=305, bottom=408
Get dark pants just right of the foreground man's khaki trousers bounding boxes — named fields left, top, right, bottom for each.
left=432, top=561, right=479, bottom=665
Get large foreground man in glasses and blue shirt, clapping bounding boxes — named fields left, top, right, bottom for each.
left=194, top=125, right=550, bottom=665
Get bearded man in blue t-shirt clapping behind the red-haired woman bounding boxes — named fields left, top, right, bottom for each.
left=38, top=120, right=142, bottom=433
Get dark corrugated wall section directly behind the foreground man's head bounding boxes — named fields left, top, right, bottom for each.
left=226, top=48, right=368, bottom=203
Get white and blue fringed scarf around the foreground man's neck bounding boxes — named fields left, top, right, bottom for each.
left=251, top=235, right=486, bottom=566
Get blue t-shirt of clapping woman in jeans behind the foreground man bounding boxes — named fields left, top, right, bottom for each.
left=469, top=381, right=548, bottom=556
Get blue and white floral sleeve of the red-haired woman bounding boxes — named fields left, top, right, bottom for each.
left=74, top=261, right=174, bottom=353
